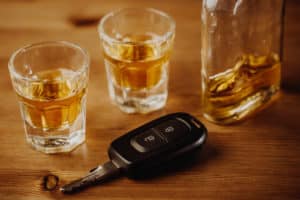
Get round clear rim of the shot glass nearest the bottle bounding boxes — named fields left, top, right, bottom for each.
left=98, top=7, right=176, bottom=45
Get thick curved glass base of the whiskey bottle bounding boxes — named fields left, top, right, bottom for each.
left=203, top=86, right=279, bottom=125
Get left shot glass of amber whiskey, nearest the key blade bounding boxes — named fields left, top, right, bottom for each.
left=8, top=41, right=90, bottom=153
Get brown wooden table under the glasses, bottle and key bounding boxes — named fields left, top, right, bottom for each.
left=0, top=0, right=300, bottom=200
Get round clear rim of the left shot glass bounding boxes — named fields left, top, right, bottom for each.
left=8, top=40, right=90, bottom=81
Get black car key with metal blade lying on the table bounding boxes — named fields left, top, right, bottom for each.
left=60, top=113, right=207, bottom=193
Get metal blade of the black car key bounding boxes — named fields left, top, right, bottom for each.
left=60, top=161, right=120, bottom=194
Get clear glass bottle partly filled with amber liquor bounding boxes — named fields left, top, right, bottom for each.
left=201, top=0, right=284, bottom=124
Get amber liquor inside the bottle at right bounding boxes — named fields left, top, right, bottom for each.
left=204, top=54, right=281, bottom=124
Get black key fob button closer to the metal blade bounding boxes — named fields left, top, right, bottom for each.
left=130, top=129, right=165, bottom=153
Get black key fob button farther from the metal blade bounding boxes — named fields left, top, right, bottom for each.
left=154, top=119, right=190, bottom=142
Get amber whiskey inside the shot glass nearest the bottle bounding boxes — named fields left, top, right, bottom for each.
left=104, top=34, right=169, bottom=90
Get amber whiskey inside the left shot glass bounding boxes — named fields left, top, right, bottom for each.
left=18, top=69, right=86, bottom=130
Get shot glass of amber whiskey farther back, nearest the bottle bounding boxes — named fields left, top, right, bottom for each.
left=98, top=8, right=175, bottom=113
